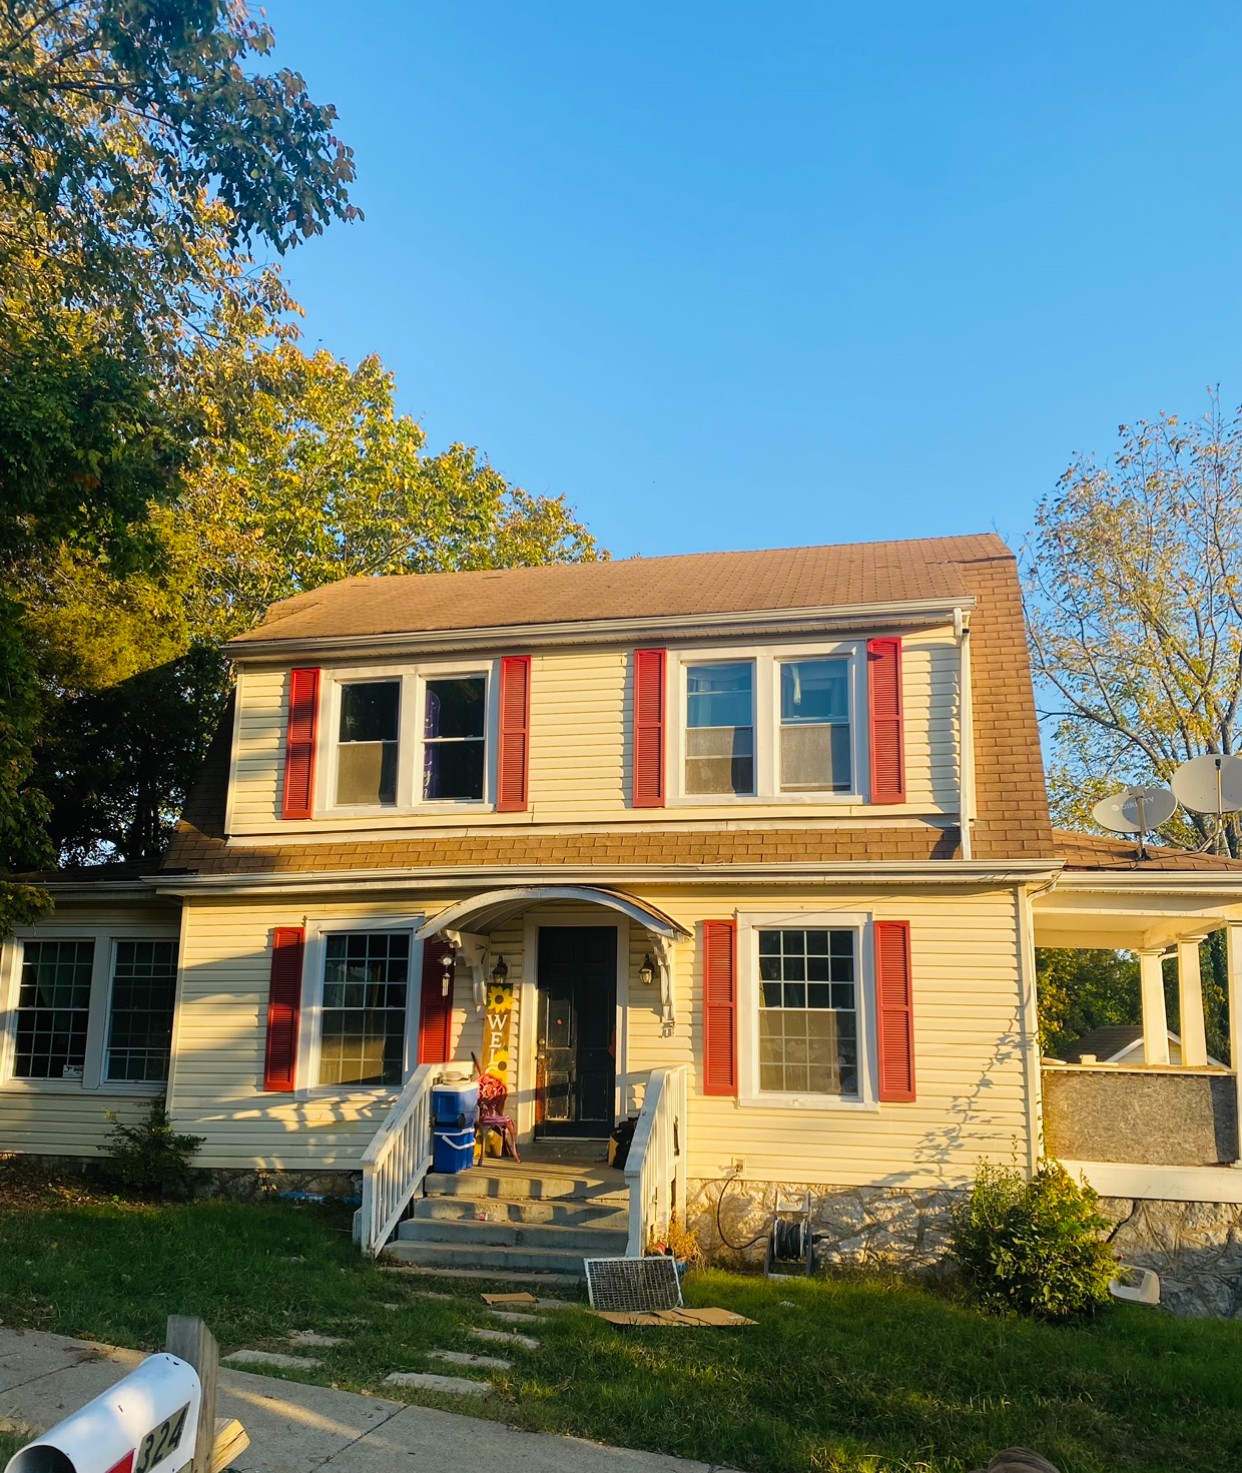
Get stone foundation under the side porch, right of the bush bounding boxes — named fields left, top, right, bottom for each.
left=1101, top=1198, right=1242, bottom=1320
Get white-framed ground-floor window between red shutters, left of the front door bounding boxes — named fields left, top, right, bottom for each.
left=298, top=915, right=423, bottom=1094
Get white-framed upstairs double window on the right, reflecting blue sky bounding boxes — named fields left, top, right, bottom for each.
left=667, top=641, right=866, bottom=804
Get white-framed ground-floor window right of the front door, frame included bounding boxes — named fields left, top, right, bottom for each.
left=738, top=912, right=875, bottom=1109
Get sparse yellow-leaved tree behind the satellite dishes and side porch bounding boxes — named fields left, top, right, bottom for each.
left=1025, top=395, right=1242, bottom=1058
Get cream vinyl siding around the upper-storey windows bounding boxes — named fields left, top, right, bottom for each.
left=230, top=627, right=959, bottom=841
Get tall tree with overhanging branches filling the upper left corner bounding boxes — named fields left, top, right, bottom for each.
left=0, top=0, right=354, bottom=935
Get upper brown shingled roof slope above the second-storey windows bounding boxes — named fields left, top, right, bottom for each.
left=225, top=533, right=1008, bottom=650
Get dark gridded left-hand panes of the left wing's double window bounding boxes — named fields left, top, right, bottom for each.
left=13, top=941, right=94, bottom=1080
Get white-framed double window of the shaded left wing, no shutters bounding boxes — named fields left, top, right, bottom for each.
left=0, top=927, right=178, bottom=1094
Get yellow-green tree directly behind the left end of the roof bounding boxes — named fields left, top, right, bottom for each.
left=23, top=343, right=597, bottom=862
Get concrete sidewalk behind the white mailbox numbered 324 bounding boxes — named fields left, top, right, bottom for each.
left=0, top=1327, right=739, bottom=1473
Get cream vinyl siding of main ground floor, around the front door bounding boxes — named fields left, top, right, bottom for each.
left=162, top=887, right=1027, bottom=1187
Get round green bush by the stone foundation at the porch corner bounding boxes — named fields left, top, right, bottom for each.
left=950, top=1161, right=1117, bottom=1320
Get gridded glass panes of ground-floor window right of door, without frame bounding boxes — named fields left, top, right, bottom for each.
left=759, top=929, right=857, bottom=1096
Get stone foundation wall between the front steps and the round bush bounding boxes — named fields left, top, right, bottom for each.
left=687, top=1181, right=962, bottom=1271
